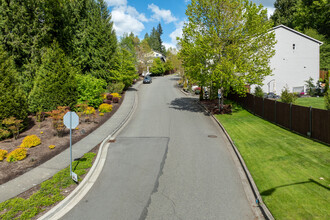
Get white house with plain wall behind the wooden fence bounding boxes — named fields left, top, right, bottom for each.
left=251, top=25, right=322, bottom=95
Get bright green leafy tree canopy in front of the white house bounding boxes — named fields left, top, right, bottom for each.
left=179, top=0, right=275, bottom=98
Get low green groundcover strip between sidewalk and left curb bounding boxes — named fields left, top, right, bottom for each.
left=0, top=152, right=96, bottom=219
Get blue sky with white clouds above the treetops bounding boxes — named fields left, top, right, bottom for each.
left=105, top=0, right=275, bottom=48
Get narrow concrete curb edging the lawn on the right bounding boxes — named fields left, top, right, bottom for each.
left=197, top=102, right=275, bottom=220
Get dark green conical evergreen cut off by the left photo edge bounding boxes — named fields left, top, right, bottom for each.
left=0, top=46, right=28, bottom=121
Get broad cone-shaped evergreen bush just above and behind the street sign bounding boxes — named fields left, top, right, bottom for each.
left=29, top=43, right=78, bottom=112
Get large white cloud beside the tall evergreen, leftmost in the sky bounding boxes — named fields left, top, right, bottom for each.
left=111, top=6, right=146, bottom=36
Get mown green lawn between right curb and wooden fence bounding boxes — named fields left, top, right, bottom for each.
left=216, top=110, right=330, bottom=219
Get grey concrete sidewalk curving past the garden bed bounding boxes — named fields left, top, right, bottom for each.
left=0, top=82, right=141, bottom=203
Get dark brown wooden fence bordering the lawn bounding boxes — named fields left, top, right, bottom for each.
left=228, top=93, right=330, bottom=144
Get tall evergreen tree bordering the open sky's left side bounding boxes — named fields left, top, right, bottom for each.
left=73, top=0, right=117, bottom=82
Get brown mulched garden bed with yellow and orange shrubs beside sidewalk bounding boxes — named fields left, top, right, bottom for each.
left=0, top=93, right=123, bottom=184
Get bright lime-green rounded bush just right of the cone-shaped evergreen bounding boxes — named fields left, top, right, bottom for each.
left=76, top=74, right=107, bottom=107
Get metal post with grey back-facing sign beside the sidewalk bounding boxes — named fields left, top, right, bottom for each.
left=63, top=112, right=79, bottom=182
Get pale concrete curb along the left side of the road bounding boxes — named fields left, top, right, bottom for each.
left=38, top=84, right=141, bottom=220
